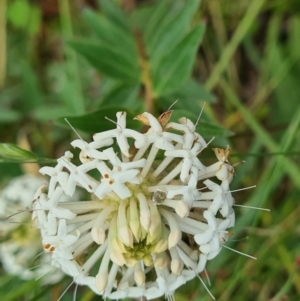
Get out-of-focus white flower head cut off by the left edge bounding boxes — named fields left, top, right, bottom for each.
left=0, top=174, right=63, bottom=283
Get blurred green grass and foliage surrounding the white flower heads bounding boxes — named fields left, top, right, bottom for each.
left=0, top=0, right=300, bottom=301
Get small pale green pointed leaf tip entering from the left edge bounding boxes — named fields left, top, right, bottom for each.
left=0, top=143, right=37, bottom=161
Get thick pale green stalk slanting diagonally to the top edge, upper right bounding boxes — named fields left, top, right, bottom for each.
left=205, top=0, right=265, bottom=90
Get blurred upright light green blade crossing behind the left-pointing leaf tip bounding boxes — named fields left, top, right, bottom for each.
left=58, top=0, right=85, bottom=114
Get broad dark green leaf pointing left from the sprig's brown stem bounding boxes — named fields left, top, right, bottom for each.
left=69, top=40, right=140, bottom=83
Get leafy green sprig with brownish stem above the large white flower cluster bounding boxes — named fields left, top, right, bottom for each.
left=69, top=0, right=212, bottom=116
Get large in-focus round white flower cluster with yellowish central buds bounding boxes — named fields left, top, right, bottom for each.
left=33, top=111, right=239, bottom=299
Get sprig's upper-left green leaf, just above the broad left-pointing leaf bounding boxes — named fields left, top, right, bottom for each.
left=83, top=9, right=138, bottom=61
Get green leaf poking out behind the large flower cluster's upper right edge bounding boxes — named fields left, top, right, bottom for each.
left=172, top=110, right=233, bottom=139
